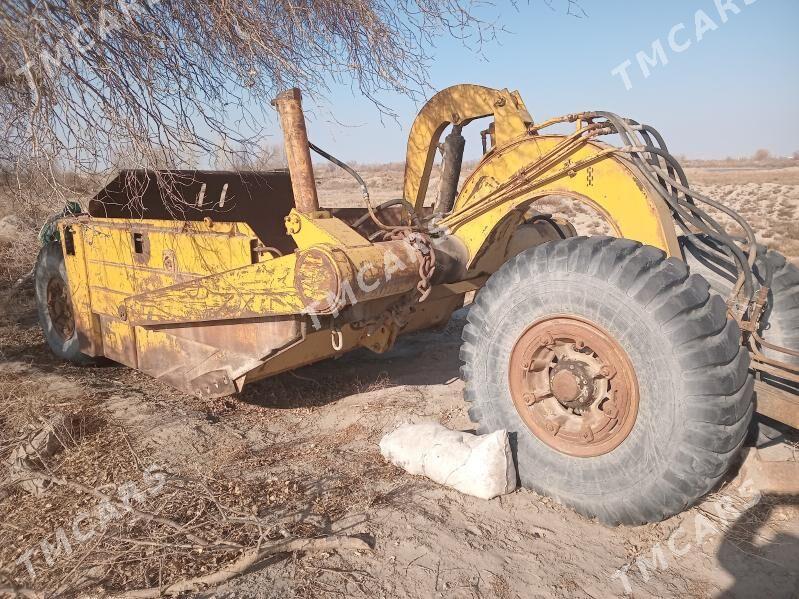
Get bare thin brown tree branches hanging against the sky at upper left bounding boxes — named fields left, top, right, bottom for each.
left=0, top=0, right=576, bottom=202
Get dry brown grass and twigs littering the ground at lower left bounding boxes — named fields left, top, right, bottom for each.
left=0, top=366, right=396, bottom=596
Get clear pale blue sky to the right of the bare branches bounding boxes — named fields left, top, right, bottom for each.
left=268, top=0, right=799, bottom=162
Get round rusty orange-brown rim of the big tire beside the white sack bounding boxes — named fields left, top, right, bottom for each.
left=509, top=315, right=639, bottom=457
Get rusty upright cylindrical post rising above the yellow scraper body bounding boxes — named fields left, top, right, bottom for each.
left=272, top=87, right=319, bottom=214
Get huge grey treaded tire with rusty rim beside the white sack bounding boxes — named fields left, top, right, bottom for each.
left=461, top=237, right=753, bottom=524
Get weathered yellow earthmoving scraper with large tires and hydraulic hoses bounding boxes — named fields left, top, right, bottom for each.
left=36, top=85, right=799, bottom=523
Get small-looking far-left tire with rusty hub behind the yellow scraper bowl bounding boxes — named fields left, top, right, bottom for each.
left=34, top=241, right=93, bottom=364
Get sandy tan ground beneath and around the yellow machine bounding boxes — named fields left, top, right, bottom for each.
left=0, top=165, right=799, bottom=599
